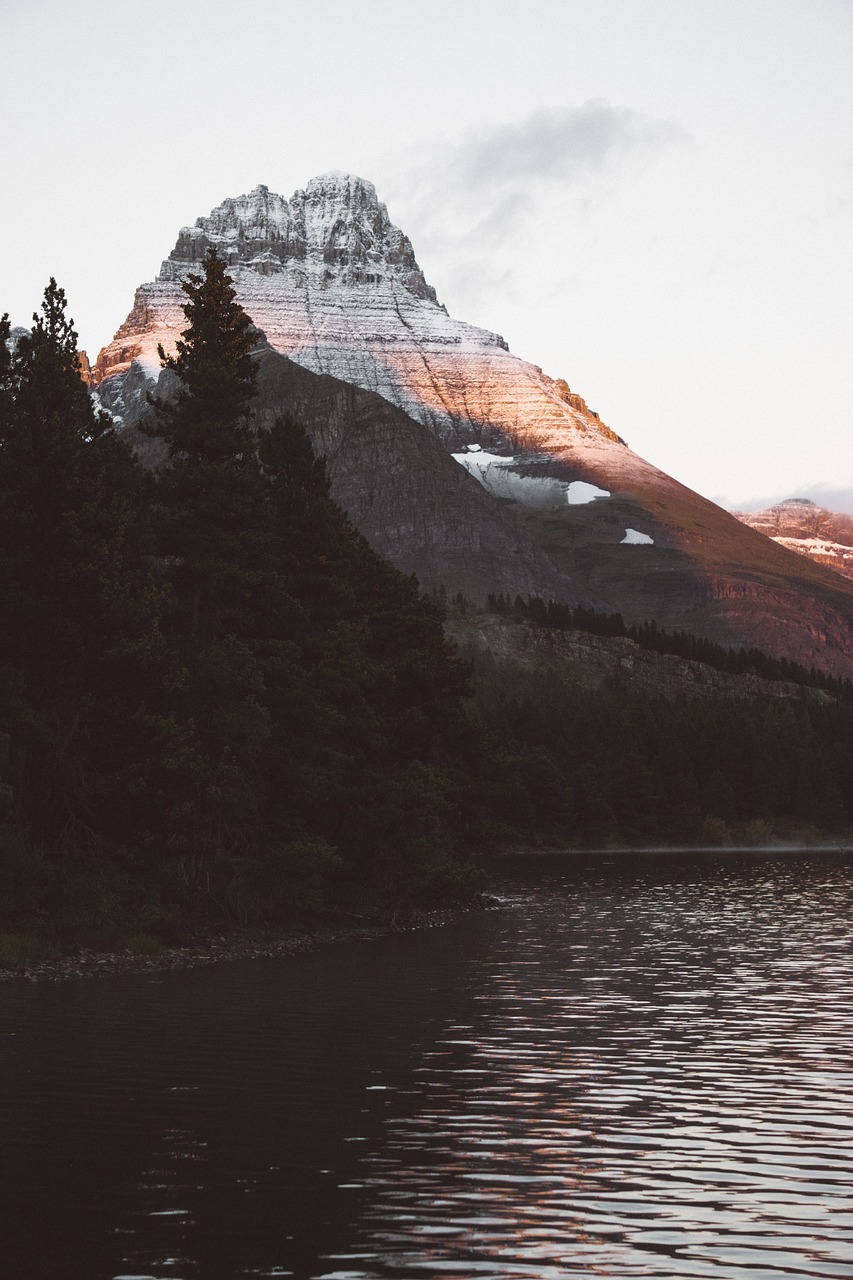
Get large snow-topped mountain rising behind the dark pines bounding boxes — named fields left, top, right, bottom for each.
left=92, top=173, right=853, bottom=675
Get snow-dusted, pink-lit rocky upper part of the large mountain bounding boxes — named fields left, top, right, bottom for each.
left=93, top=172, right=625, bottom=470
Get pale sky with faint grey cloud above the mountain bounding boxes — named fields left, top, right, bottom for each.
left=0, top=0, right=853, bottom=511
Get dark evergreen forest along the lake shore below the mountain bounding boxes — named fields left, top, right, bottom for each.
left=0, top=252, right=853, bottom=946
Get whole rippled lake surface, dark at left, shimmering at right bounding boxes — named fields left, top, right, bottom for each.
left=0, top=858, right=853, bottom=1280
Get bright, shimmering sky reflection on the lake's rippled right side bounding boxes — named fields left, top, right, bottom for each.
left=325, top=849, right=853, bottom=1280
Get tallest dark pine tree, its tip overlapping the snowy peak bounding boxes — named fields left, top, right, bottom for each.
left=147, top=250, right=280, bottom=880
